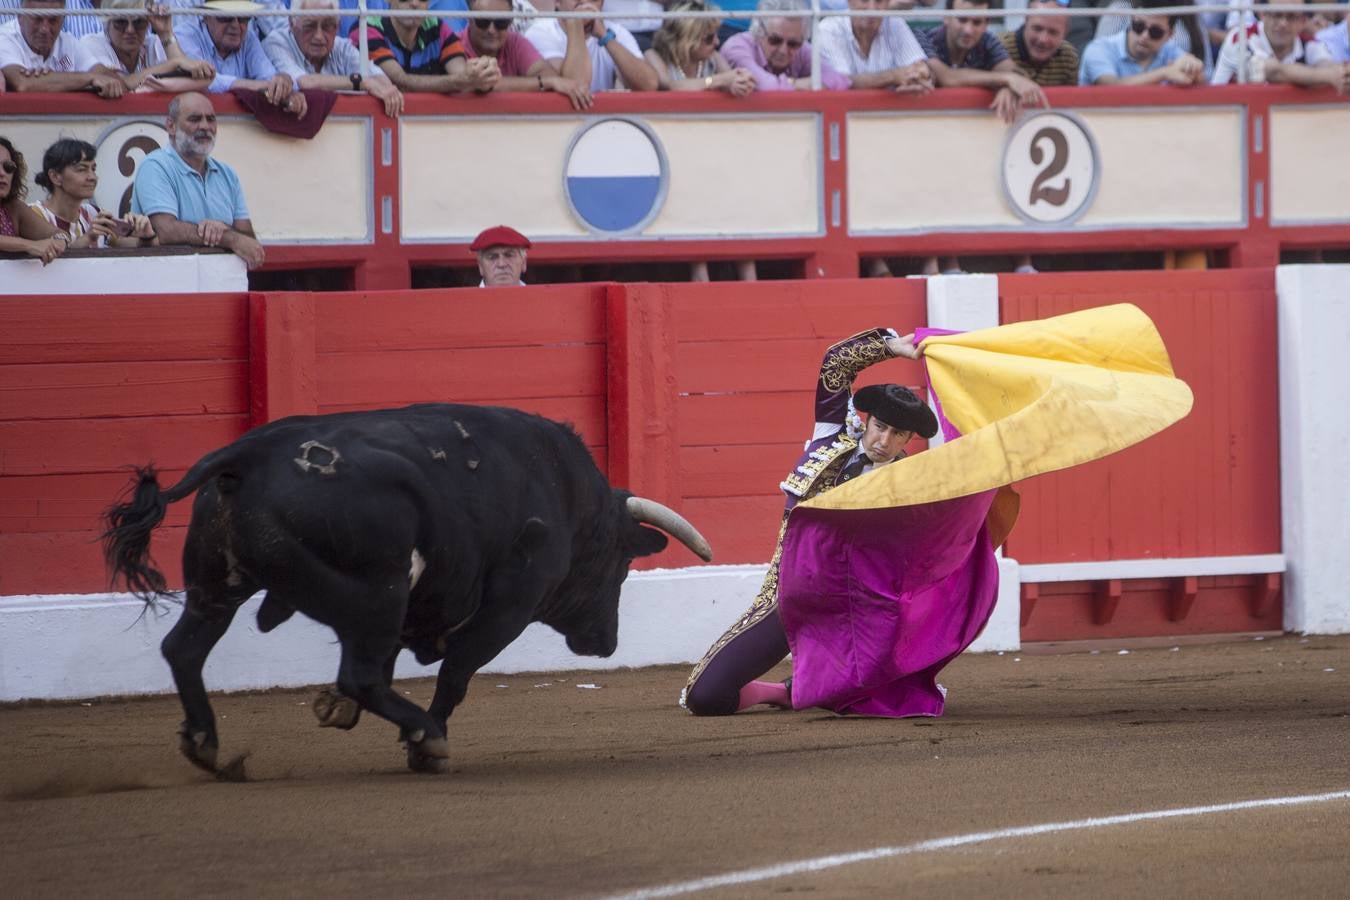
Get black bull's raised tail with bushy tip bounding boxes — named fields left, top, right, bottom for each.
left=103, top=447, right=244, bottom=606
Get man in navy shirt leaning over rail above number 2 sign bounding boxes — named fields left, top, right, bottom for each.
left=923, top=0, right=1046, bottom=123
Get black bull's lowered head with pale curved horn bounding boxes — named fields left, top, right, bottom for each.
left=551, top=490, right=713, bottom=657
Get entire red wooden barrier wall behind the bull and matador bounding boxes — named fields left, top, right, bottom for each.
left=0, top=271, right=1280, bottom=640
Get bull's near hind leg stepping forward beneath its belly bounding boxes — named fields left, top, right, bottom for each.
left=338, top=631, right=450, bottom=773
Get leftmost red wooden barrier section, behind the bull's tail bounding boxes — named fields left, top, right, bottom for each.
left=0, top=294, right=248, bottom=595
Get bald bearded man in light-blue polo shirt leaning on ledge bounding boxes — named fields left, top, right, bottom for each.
left=131, top=92, right=265, bottom=269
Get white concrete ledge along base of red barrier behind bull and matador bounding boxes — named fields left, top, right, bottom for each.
left=0, top=560, right=1018, bottom=703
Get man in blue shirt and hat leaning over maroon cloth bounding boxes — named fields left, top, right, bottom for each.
left=174, top=0, right=308, bottom=119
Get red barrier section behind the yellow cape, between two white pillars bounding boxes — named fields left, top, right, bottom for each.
left=999, top=270, right=1281, bottom=640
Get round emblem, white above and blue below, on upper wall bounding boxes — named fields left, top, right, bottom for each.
left=563, top=119, right=668, bottom=235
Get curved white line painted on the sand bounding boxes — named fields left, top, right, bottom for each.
left=608, top=791, right=1350, bottom=900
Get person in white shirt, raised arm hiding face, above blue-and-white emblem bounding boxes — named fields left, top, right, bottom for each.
left=525, top=0, right=660, bottom=93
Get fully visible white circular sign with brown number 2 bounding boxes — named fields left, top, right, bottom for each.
left=1003, top=112, right=1102, bottom=225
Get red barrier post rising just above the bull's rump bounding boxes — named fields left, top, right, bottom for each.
left=248, top=293, right=319, bottom=428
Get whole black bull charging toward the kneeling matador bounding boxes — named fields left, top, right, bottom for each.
left=104, top=403, right=711, bottom=775
